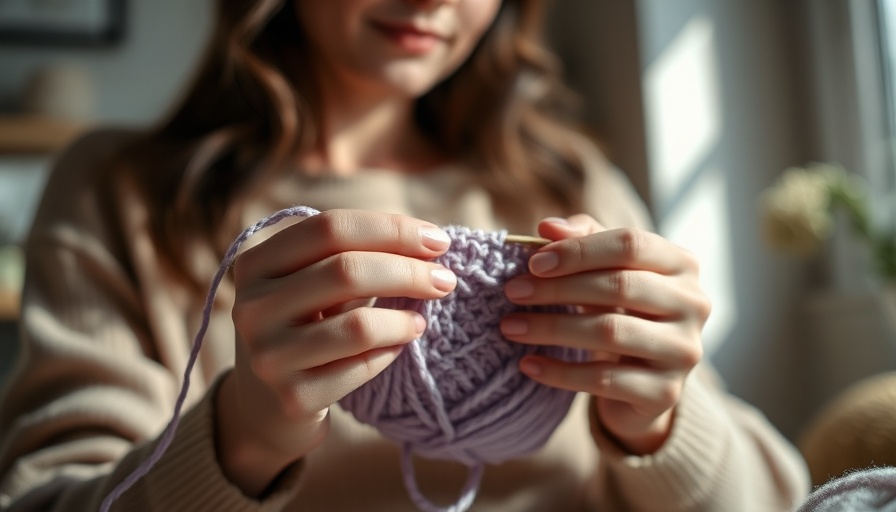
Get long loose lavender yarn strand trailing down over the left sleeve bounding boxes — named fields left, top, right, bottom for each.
left=100, top=206, right=320, bottom=512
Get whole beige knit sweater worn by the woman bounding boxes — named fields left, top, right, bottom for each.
left=0, top=132, right=809, bottom=512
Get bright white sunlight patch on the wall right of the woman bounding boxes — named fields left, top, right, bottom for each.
left=644, top=16, right=737, bottom=352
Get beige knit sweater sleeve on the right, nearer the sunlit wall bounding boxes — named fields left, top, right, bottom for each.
left=583, top=137, right=810, bottom=512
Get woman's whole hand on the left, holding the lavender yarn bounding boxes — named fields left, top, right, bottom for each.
left=216, top=210, right=456, bottom=496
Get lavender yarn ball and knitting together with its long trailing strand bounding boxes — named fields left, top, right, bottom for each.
left=101, top=206, right=586, bottom=512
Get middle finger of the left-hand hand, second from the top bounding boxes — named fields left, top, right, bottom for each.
left=237, top=252, right=457, bottom=321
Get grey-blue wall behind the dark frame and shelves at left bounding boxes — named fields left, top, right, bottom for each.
left=0, top=0, right=211, bottom=380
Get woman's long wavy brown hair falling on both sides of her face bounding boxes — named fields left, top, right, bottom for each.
left=122, top=0, right=582, bottom=284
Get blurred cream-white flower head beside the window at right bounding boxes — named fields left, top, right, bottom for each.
left=760, top=164, right=846, bottom=255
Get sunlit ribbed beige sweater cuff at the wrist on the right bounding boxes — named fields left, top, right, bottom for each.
left=589, top=374, right=736, bottom=511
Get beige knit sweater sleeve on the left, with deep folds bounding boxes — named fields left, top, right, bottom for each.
left=0, top=132, right=298, bottom=511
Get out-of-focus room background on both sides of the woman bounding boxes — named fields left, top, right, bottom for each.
left=0, top=0, right=896, bottom=472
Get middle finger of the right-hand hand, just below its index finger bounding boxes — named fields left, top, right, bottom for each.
left=504, top=270, right=706, bottom=320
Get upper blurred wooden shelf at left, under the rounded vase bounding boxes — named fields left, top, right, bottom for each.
left=0, top=115, right=88, bottom=155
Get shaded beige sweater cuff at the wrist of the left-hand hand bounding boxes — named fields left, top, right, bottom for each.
left=109, top=372, right=301, bottom=512
